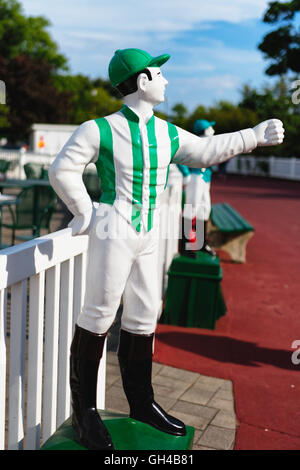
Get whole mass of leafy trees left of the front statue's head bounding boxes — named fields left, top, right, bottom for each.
left=0, top=0, right=121, bottom=141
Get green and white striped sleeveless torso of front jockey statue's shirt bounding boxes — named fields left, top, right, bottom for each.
left=96, top=106, right=179, bottom=231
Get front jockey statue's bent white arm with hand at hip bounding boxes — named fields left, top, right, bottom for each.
left=49, top=121, right=100, bottom=235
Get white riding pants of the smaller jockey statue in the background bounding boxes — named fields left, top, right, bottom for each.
left=183, top=173, right=211, bottom=220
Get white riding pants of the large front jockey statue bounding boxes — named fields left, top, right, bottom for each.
left=77, top=203, right=161, bottom=334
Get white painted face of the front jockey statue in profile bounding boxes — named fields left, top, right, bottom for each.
left=140, top=67, right=168, bottom=106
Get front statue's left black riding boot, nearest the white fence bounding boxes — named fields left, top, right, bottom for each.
left=70, top=325, right=114, bottom=450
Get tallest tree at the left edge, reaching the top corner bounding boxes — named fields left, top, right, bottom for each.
left=0, top=0, right=70, bottom=141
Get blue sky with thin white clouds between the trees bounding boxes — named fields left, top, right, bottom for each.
left=20, top=0, right=271, bottom=112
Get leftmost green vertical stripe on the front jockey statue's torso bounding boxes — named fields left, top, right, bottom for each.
left=95, top=118, right=116, bottom=205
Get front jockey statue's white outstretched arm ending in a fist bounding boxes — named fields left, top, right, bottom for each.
left=172, top=119, right=284, bottom=168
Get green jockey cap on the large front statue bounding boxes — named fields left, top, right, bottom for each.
left=108, top=49, right=170, bottom=86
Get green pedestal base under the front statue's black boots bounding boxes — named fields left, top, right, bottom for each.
left=41, top=410, right=195, bottom=450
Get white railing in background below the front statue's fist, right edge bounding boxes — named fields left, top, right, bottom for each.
left=227, top=155, right=300, bottom=180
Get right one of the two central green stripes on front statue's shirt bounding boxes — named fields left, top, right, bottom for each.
left=147, top=116, right=158, bottom=231
